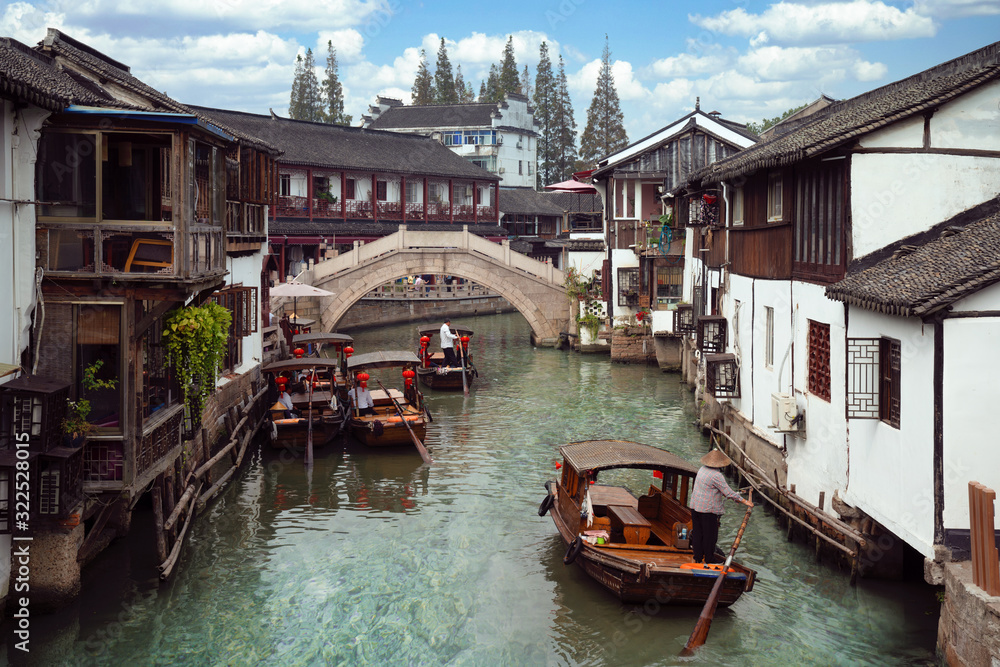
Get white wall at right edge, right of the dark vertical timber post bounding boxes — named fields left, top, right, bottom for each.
left=944, top=316, right=1000, bottom=530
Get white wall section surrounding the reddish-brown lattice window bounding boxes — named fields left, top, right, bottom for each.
left=784, top=282, right=847, bottom=507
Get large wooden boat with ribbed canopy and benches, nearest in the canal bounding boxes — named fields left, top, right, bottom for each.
left=538, top=440, right=756, bottom=606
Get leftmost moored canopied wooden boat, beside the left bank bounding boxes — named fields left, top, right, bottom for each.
left=263, top=357, right=347, bottom=449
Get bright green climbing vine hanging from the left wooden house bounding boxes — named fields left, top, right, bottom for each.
left=163, top=302, right=233, bottom=418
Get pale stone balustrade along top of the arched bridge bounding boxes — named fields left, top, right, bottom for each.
left=314, top=225, right=564, bottom=285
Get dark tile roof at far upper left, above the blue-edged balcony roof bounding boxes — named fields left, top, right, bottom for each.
left=0, top=37, right=116, bottom=111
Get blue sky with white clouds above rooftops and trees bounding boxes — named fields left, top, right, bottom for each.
left=0, top=0, right=1000, bottom=142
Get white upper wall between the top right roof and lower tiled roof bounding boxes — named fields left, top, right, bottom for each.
left=851, top=153, right=1000, bottom=258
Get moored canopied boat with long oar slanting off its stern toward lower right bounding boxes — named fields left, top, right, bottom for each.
left=347, top=351, right=428, bottom=447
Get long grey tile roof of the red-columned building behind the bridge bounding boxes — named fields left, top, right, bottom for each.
left=191, top=106, right=500, bottom=182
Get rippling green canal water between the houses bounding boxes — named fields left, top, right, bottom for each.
left=3, top=314, right=939, bottom=666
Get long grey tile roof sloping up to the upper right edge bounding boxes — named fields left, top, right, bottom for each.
left=691, top=42, right=1000, bottom=186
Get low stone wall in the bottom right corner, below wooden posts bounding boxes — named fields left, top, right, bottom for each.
left=937, top=561, right=1000, bottom=667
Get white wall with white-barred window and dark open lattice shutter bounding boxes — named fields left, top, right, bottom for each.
left=842, top=308, right=947, bottom=558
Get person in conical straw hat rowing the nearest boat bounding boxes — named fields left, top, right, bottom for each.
left=691, top=449, right=753, bottom=563
